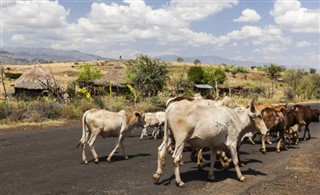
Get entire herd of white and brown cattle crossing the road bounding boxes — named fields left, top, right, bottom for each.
left=77, top=96, right=320, bottom=187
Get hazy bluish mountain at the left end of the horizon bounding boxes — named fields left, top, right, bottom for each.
left=0, top=47, right=106, bottom=64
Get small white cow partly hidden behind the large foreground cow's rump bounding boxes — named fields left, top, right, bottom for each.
left=140, top=112, right=166, bottom=139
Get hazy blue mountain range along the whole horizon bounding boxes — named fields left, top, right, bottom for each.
left=0, top=47, right=320, bottom=72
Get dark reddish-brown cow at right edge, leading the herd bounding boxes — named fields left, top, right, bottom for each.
left=293, top=105, right=320, bottom=140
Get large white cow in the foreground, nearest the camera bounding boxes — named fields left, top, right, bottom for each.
left=153, top=100, right=267, bottom=186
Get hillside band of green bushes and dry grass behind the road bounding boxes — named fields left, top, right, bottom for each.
left=0, top=57, right=320, bottom=124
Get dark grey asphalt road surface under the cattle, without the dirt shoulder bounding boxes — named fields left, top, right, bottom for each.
left=0, top=104, right=320, bottom=194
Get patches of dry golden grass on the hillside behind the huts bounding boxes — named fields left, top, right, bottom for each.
left=0, top=61, right=283, bottom=101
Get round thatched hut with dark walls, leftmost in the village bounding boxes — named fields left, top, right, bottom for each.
left=14, top=65, right=60, bottom=96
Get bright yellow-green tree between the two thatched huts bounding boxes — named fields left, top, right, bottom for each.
left=77, top=63, right=102, bottom=81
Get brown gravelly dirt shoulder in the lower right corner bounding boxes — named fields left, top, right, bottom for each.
left=192, top=141, right=320, bottom=195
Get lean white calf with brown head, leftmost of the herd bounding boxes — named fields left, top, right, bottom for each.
left=77, top=109, right=141, bottom=164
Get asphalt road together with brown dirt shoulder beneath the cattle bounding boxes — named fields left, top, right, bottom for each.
left=0, top=105, right=320, bottom=194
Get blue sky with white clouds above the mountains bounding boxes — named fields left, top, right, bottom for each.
left=0, top=0, right=320, bottom=69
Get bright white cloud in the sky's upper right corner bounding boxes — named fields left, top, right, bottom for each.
left=270, top=0, right=320, bottom=33
